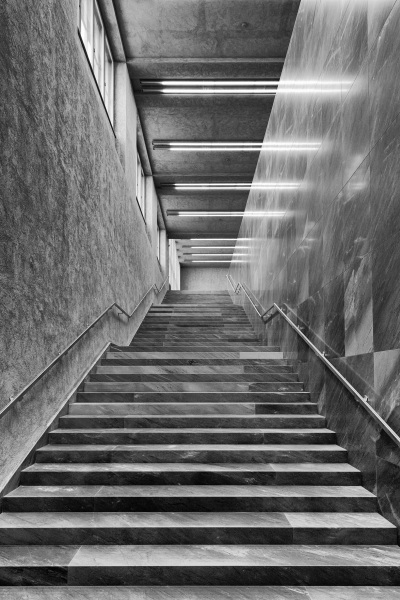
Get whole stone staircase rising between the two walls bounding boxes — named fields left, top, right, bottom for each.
left=0, top=291, right=400, bottom=600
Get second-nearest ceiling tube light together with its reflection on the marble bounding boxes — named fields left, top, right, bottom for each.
left=152, top=140, right=321, bottom=152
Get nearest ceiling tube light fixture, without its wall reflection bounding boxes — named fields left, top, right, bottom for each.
left=140, top=79, right=278, bottom=96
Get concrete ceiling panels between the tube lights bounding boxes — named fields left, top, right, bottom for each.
left=114, top=0, right=300, bottom=266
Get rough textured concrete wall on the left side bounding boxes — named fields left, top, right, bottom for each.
left=0, top=0, right=163, bottom=488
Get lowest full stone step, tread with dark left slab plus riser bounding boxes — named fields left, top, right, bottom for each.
left=0, top=544, right=400, bottom=586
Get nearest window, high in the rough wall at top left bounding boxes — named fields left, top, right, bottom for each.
left=79, top=0, right=114, bottom=123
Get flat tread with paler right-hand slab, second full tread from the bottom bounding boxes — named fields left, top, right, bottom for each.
left=0, top=511, right=390, bottom=531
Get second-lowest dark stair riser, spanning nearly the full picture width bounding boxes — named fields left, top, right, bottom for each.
left=0, top=526, right=397, bottom=546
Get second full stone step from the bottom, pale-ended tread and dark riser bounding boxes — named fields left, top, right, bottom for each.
left=0, top=512, right=397, bottom=546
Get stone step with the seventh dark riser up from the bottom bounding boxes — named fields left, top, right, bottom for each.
left=59, top=414, right=326, bottom=431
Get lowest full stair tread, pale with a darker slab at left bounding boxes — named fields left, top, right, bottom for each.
left=0, top=545, right=400, bottom=569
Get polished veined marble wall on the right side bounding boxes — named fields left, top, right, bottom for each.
left=230, top=0, right=400, bottom=524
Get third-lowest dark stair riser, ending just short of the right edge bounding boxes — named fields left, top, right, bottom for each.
left=4, top=490, right=376, bottom=512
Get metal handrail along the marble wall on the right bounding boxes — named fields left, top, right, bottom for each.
left=227, top=276, right=400, bottom=448
